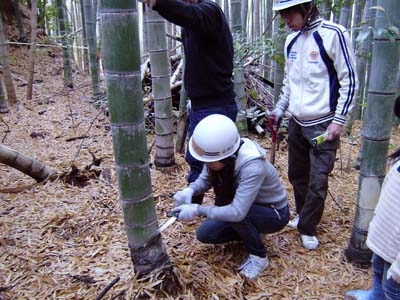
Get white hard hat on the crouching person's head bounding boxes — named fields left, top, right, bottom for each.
left=189, top=114, right=240, bottom=162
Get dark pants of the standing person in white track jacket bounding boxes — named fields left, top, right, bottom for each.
left=288, top=119, right=340, bottom=235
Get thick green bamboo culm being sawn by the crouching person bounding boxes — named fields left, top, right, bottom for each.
left=100, top=0, right=169, bottom=275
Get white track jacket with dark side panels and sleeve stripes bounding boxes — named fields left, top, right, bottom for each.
left=276, top=18, right=358, bottom=126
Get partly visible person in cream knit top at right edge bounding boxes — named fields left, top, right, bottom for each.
left=345, top=97, right=400, bottom=300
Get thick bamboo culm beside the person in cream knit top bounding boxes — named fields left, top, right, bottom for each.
left=345, top=0, right=400, bottom=265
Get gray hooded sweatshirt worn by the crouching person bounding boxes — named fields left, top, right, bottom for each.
left=194, top=138, right=288, bottom=222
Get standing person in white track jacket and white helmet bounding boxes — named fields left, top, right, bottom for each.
left=269, top=0, right=358, bottom=250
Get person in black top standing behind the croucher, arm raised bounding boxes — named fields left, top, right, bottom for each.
left=144, top=0, right=238, bottom=203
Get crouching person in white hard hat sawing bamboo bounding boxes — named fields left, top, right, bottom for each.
left=173, top=114, right=290, bottom=280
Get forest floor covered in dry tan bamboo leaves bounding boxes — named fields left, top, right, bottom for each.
left=0, top=41, right=400, bottom=300
